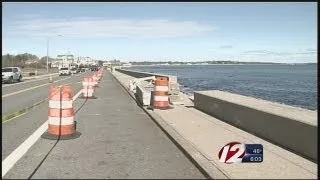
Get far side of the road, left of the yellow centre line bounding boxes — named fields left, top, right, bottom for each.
left=2, top=72, right=92, bottom=115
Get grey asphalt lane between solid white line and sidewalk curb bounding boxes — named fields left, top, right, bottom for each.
left=3, top=73, right=204, bottom=179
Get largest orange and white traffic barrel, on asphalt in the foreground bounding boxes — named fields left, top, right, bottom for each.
left=42, top=86, right=80, bottom=139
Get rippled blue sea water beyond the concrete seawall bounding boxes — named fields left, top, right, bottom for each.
left=128, top=65, right=317, bottom=110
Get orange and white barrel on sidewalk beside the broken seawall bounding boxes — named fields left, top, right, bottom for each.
left=153, top=77, right=169, bottom=109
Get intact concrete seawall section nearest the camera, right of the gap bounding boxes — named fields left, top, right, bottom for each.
left=194, top=91, right=317, bottom=161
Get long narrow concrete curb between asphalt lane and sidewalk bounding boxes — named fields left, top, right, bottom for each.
left=109, top=72, right=230, bottom=179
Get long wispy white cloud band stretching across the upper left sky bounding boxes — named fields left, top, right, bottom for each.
left=6, top=17, right=215, bottom=38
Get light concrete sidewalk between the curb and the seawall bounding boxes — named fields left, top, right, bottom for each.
left=113, top=71, right=317, bottom=179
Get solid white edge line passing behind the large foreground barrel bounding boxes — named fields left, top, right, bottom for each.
left=2, top=90, right=82, bottom=178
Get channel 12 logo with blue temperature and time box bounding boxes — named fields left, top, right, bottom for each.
left=218, top=142, right=263, bottom=164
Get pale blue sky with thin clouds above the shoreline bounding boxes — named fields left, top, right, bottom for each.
left=2, top=2, right=317, bottom=63
